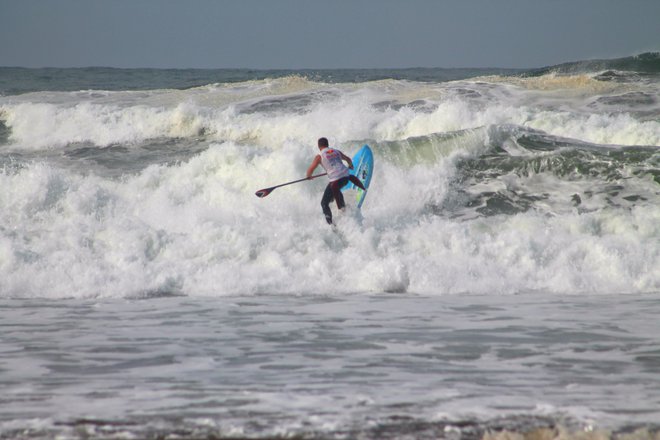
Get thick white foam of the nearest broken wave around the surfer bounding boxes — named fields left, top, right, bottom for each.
left=0, top=137, right=660, bottom=297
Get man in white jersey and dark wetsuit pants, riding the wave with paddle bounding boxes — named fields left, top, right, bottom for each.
left=307, top=138, right=365, bottom=225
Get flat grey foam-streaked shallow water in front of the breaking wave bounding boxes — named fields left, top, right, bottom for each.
left=0, top=294, right=660, bottom=438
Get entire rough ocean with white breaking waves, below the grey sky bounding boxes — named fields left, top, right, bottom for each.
left=0, top=53, right=660, bottom=440
